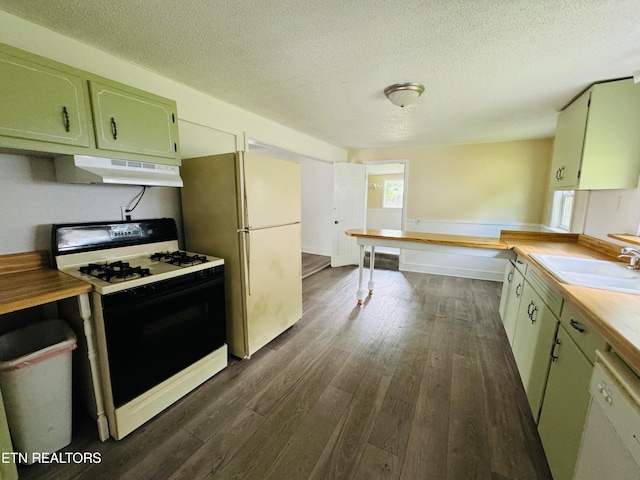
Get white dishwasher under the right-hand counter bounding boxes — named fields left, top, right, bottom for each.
left=574, top=352, right=640, bottom=480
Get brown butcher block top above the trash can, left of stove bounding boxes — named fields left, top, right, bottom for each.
left=0, top=251, right=91, bottom=314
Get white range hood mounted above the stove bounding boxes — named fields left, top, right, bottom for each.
left=55, top=155, right=182, bottom=187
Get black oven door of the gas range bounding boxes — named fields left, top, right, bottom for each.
left=101, top=266, right=225, bottom=408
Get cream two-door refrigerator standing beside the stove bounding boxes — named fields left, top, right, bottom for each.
left=181, top=152, right=302, bottom=358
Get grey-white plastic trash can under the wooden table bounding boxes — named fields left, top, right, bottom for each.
left=0, top=320, right=76, bottom=464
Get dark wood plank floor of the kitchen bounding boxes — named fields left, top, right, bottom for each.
left=20, top=267, right=551, bottom=480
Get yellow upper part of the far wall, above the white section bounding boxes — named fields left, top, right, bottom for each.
left=349, top=139, right=552, bottom=228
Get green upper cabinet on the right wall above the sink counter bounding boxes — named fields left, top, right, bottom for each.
left=550, top=79, right=640, bottom=190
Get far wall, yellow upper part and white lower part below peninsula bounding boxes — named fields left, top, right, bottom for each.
left=349, top=139, right=552, bottom=281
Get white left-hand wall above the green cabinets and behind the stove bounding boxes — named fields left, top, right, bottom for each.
left=0, top=11, right=347, bottom=254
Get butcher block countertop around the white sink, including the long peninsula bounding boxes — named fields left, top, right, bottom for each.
left=346, top=229, right=640, bottom=375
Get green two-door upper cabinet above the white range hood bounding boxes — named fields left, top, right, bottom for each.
left=0, top=44, right=181, bottom=165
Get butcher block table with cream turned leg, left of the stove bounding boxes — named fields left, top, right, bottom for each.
left=0, top=251, right=109, bottom=441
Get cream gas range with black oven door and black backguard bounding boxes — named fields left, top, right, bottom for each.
left=52, top=218, right=227, bottom=440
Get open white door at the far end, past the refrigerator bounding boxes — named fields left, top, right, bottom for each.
left=331, top=163, right=367, bottom=267
